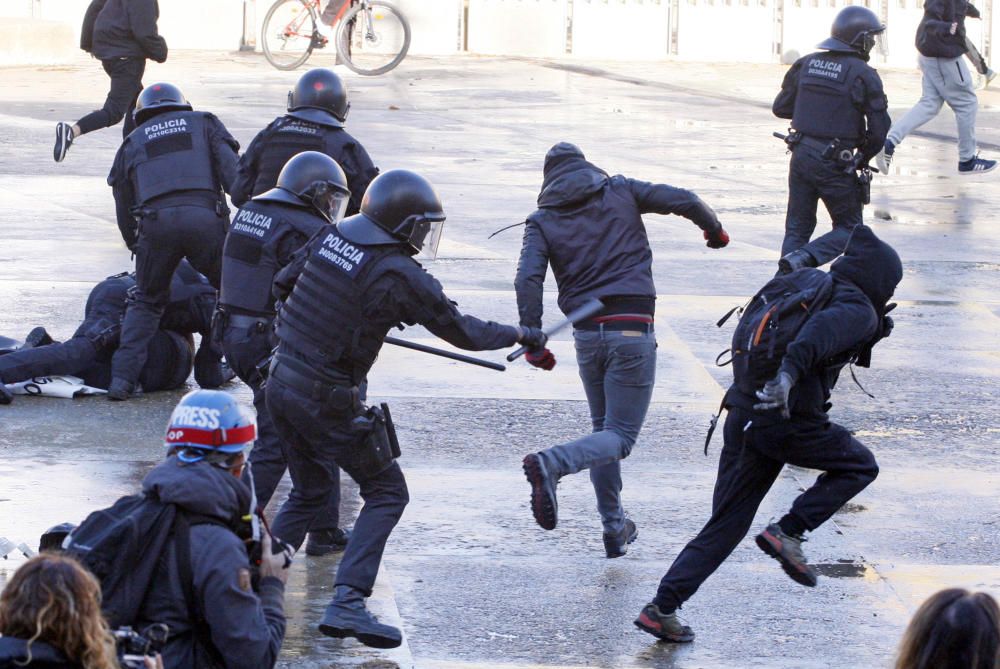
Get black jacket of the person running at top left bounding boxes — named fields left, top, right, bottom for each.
left=87, top=0, right=167, bottom=63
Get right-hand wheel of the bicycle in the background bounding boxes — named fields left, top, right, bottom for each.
left=336, top=0, right=410, bottom=76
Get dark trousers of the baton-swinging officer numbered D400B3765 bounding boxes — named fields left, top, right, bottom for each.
left=266, top=375, right=410, bottom=595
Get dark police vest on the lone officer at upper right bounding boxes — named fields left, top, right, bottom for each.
left=792, top=51, right=868, bottom=146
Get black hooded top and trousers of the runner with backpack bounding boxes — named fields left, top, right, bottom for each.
left=653, top=226, right=903, bottom=613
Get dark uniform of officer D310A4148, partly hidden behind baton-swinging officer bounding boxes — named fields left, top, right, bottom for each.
left=219, top=199, right=332, bottom=516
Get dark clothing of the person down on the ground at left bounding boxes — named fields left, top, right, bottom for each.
left=0, top=263, right=215, bottom=391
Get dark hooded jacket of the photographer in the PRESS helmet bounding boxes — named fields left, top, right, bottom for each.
left=137, top=457, right=285, bottom=669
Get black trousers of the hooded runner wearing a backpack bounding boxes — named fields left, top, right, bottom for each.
left=653, top=408, right=878, bottom=611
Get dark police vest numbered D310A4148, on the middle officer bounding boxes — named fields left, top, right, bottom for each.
left=219, top=200, right=325, bottom=315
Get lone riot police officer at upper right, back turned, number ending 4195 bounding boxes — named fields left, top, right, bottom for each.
left=772, top=6, right=890, bottom=272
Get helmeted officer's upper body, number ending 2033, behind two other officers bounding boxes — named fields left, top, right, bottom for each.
left=232, top=68, right=378, bottom=216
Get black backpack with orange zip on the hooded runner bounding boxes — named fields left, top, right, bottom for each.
left=718, top=268, right=833, bottom=395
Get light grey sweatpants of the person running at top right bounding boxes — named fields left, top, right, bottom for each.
left=889, top=56, right=979, bottom=162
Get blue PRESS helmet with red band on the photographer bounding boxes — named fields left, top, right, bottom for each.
left=164, top=389, right=257, bottom=467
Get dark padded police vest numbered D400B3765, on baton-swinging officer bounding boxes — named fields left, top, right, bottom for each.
left=276, top=228, right=414, bottom=383
